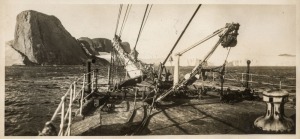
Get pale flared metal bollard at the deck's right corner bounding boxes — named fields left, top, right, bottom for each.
left=254, top=89, right=295, bottom=132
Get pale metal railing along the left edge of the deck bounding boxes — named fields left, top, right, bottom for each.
left=45, top=70, right=98, bottom=136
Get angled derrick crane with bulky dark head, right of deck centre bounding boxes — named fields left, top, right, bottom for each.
left=156, top=23, right=240, bottom=102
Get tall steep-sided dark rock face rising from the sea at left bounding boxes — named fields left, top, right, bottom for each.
left=13, top=10, right=87, bottom=65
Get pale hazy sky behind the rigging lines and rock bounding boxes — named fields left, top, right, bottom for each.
left=4, top=4, right=296, bottom=65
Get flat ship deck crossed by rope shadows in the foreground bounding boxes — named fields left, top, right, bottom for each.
left=71, top=92, right=296, bottom=136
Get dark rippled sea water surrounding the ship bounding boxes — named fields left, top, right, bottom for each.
left=5, top=66, right=296, bottom=136
